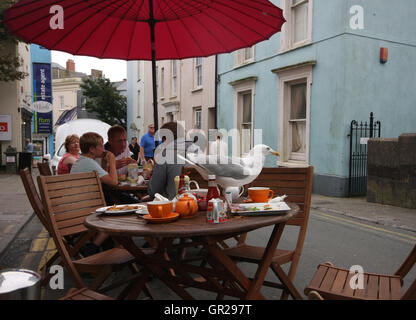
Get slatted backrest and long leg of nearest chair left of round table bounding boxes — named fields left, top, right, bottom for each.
left=38, top=171, right=106, bottom=287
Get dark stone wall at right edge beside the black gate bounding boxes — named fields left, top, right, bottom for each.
left=367, top=133, right=416, bottom=209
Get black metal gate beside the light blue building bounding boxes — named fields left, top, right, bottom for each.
left=348, top=112, right=381, bottom=197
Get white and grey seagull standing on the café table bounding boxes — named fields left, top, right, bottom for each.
left=183, top=144, right=279, bottom=192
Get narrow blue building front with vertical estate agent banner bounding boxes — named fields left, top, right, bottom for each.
left=30, top=44, right=54, bottom=161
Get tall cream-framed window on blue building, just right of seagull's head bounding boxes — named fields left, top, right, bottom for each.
left=277, top=65, right=312, bottom=166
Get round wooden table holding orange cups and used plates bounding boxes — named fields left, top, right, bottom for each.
left=85, top=204, right=301, bottom=299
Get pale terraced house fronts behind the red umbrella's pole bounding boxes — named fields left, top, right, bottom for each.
left=127, top=56, right=216, bottom=151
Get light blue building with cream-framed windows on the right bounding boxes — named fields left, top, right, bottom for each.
left=217, top=0, right=416, bottom=196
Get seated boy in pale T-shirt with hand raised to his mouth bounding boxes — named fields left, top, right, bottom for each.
left=71, top=132, right=118, bottom=256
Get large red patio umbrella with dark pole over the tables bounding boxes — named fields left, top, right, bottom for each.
left=4, top=0, right=285, bottom=129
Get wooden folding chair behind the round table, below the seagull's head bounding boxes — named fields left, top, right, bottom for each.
left=224, top=166, right=313, bottom=299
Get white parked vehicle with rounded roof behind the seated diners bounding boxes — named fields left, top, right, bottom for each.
left=49, top=119, right=111, bottom=168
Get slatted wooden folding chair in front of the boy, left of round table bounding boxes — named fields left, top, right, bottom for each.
left=38, top=172, right=138, bottom=292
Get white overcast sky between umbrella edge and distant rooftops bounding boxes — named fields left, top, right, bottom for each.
left=52, top=51, right=127, bottom=82
